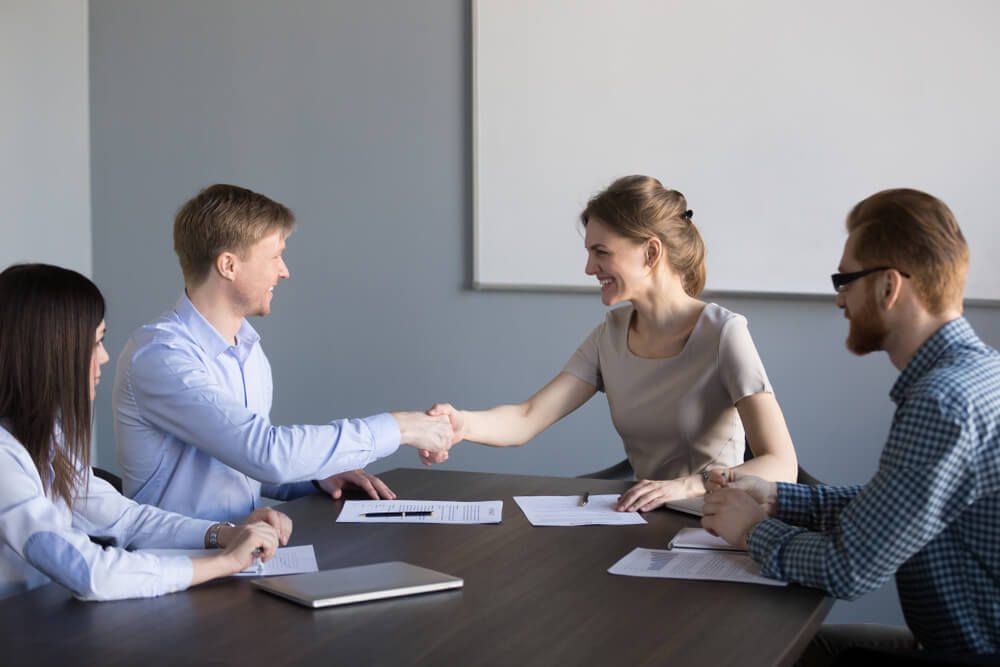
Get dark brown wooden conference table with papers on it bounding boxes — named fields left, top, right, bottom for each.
left=0, top=469, right=832, bottom=667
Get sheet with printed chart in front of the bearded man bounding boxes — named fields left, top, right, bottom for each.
left=608, top=547, right=788, bottom=586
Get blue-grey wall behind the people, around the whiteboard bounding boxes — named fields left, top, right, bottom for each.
left=91, top=0, right=1000, bottom=623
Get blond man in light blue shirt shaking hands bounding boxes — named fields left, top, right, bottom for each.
left=114, top=185, right=452, bottom=521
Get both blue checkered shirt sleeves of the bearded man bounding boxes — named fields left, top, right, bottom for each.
left=748, top=394, right=976, bottom=600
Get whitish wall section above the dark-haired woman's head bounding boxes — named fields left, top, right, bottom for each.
left=0, top=0, right=93, bottom=275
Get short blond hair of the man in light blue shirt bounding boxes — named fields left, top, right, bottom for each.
left=174, top=184, right=295, bottom=287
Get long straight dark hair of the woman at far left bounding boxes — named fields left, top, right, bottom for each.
left=0, top=264, right=104, bottom=507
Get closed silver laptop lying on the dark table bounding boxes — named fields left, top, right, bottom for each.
left=251, top=560, right=465, bottom=608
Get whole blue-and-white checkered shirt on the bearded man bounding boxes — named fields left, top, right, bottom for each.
left=748, top=318, right=1000, bottom=653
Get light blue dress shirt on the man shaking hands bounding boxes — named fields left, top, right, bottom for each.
left=113, top=295, right=400, bottom=521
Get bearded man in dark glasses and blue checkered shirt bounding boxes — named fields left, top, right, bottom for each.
left=702, top=189, right=1000, bottom=664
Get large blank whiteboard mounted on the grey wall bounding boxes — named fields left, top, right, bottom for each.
left=473, top=0, right=1000, bottom=299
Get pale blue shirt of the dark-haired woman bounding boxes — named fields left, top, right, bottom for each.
left=0, top=427, right=212, bottom=600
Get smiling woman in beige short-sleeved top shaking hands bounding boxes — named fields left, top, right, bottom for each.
left=429, top=176, right=798, bottom=511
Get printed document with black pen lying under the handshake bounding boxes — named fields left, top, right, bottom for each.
left=337, top=499, right=503, bottom=523
